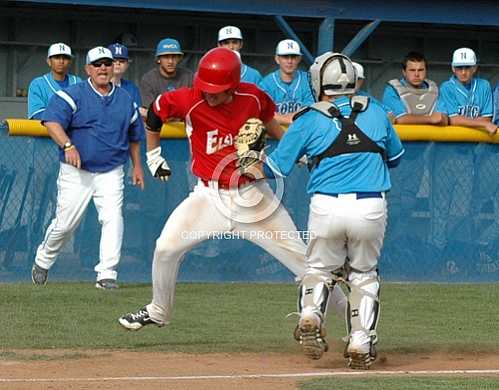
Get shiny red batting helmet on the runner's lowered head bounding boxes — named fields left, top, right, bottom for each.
left=194, top=47, right=241, bottom=93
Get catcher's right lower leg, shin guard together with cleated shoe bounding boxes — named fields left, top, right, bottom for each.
left=344, top=271, right=380, bottom=370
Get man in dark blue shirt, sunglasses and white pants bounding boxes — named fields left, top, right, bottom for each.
left=31, top=46, right=144, bottom=289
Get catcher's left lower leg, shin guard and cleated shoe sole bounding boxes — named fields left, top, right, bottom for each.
left=294, top=275, right=332, bottom=360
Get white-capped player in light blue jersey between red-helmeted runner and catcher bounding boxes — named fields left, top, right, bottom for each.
left=258, top=39, right=314, bottom=124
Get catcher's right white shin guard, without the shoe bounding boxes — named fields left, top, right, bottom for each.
left=346, top=270, right=380, bottom=343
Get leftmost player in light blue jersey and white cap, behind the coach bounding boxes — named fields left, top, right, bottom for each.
left=28, top=43, right=81, bottom=119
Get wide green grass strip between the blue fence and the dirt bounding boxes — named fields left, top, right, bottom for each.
left=0, top=283, right=499, bottom=359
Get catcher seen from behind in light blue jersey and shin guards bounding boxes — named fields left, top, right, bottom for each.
left=265, top=52, right=404, bottom=369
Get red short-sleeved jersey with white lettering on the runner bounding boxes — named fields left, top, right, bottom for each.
left=153, top=83, right=276, bottom=186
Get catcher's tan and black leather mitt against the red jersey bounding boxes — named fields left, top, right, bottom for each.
left=235, top=118, right=267, bottom=174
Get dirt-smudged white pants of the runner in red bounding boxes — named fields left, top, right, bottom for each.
left=147, top=181, right=346, bottom=323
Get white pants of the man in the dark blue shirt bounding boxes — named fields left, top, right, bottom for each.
left=35, top=163, right=124, bottom=280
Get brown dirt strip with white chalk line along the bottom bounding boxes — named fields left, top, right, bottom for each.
left=0, top=350, right=499, bottom=390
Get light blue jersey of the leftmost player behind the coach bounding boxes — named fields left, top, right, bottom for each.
left=28, top=72, right=81, bottom=119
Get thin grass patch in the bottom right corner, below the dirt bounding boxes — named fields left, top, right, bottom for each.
left=300, top=377, right=499, bottom=390
